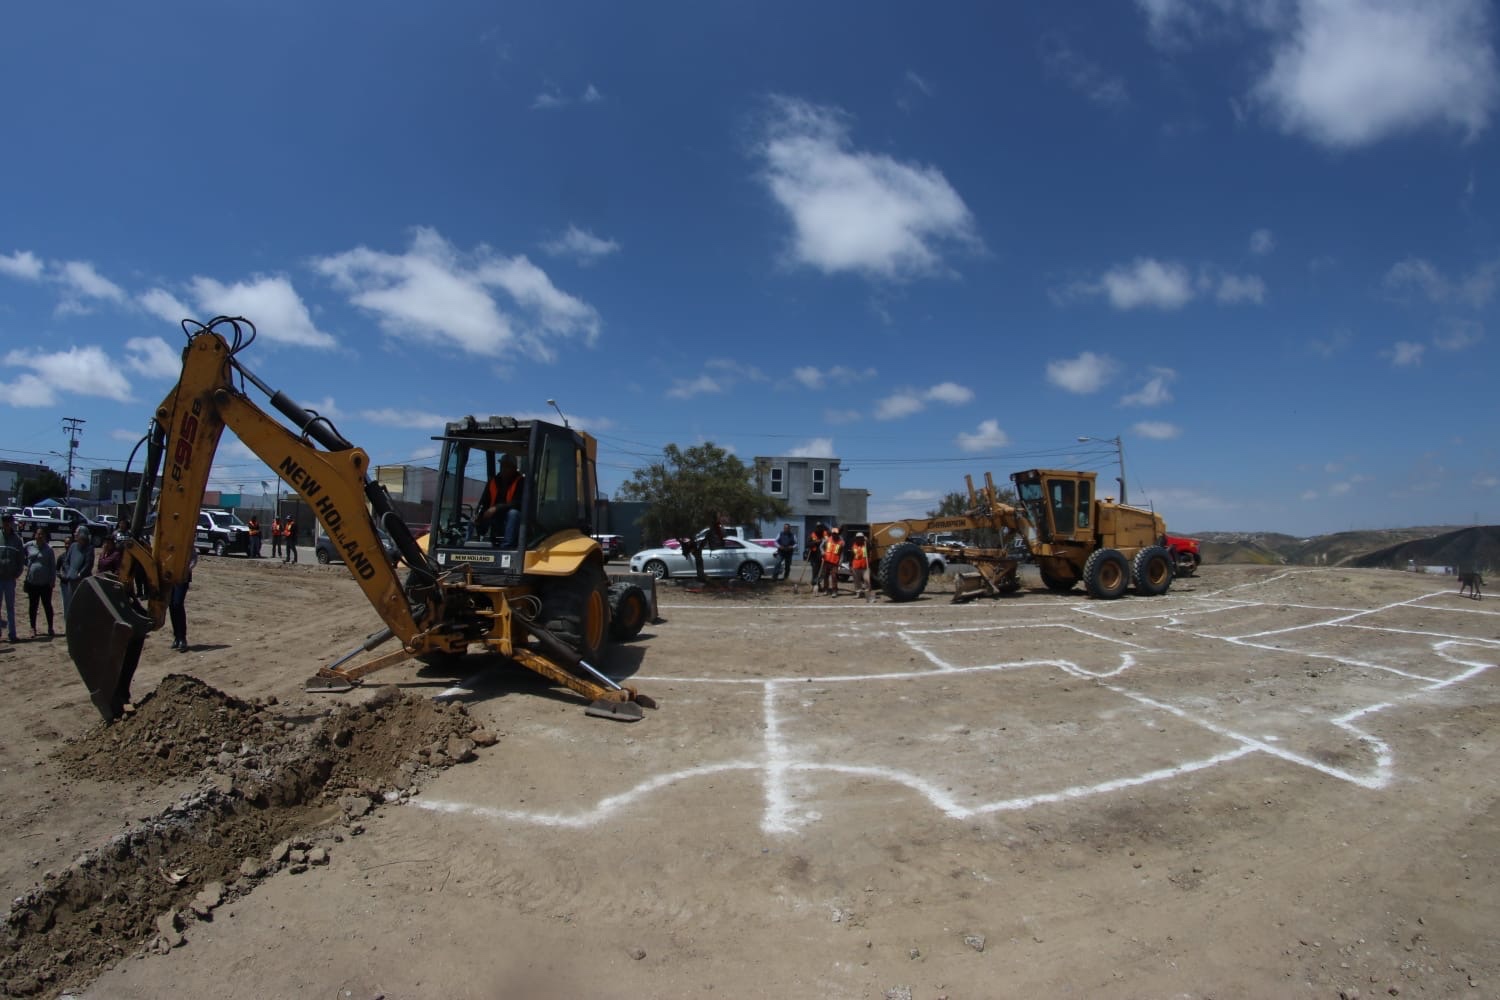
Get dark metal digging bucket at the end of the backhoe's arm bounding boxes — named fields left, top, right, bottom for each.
left=66, top=576, right=152, bottom=723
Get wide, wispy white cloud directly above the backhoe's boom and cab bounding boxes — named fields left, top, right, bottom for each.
left=314, top=226, right=600, bottom=360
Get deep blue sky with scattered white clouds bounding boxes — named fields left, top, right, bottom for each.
left=0, top=0, right=1500, bottom=535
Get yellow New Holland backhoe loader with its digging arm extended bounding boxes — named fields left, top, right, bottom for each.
left=68, top=316, right=656, bottom=721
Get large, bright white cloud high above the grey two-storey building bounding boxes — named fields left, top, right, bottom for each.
left=758, top=97, right=981, bottom=280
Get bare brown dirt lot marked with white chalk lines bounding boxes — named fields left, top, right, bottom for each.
left=0, top=558, right=1500, bottom=1000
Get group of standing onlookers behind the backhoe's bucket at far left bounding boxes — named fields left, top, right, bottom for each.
left=0, top=514, right=198, bottom=651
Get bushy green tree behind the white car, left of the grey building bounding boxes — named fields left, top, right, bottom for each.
left=615, top=441, right=788, bottom=543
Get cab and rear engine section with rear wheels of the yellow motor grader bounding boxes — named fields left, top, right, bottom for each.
left=1011, top=469, right=1173, bottom=600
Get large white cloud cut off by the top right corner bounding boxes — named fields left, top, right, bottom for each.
left=1253, top=0, right=1500, bottom=148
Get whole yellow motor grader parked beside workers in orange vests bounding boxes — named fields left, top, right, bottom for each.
left=840, top=469, right=1173, bottom=601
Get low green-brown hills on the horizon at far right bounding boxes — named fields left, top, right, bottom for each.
left=1194, top=526, right=1500, bottom=571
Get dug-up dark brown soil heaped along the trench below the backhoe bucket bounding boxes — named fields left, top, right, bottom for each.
left=0, top=675, right=495, bottom=996
